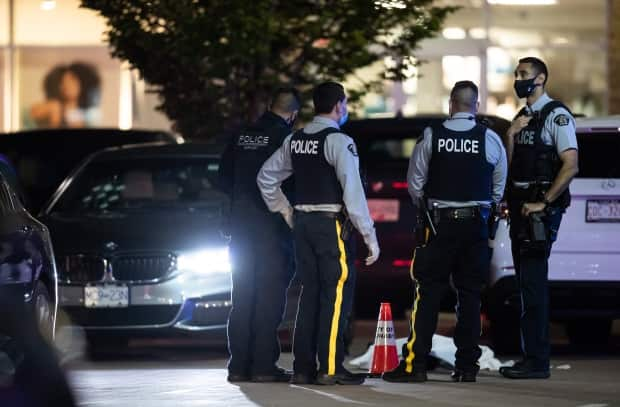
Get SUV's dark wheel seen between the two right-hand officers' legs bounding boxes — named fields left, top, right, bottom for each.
left=486, top=277, right=521, bottom=354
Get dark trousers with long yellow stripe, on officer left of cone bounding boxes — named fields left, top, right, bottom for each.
left=293, top=212, right=355, bottom=375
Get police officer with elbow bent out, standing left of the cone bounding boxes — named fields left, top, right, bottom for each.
left=257, top=82, right=379, bottom=385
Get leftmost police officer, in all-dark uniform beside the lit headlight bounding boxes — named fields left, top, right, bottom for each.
left=220, top=88, right=301, bottom=382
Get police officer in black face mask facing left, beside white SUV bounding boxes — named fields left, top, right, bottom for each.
left=500, top=57, right=578, bottom=379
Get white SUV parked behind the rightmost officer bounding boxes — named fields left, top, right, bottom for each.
left=487, top=116, right=620, bottom=350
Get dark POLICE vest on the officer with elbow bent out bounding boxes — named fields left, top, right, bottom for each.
left=290, top=128, right=343, bottom=205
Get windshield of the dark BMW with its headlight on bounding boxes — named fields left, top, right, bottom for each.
left=52, top=157, right=227, bottom=213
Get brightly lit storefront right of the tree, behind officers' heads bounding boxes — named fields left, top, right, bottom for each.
left=357, top=0, right=607, bottom=119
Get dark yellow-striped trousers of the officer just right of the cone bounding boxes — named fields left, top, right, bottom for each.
left=403, top=218, right=489, bottom=373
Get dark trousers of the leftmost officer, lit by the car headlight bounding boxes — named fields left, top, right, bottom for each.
left=228, top=213, right=294, bottom=375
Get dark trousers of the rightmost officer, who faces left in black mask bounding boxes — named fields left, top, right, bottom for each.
left=509, top=201, right=563, bottom=369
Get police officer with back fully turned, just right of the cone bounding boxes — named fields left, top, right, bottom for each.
left=383, top=81, right=507, bottom=382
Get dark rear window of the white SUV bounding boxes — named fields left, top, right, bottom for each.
left=577, top=132, right=620, bottom=178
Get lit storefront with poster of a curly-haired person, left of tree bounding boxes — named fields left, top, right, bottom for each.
left=0, top=0, right=170, bottom=131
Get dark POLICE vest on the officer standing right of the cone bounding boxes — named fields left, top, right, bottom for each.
left=424, top=124, right=494, bottom=202
